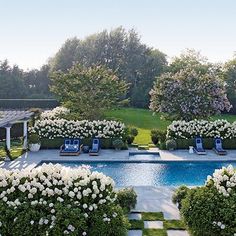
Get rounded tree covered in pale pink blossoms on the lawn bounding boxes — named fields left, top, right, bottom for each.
left=150, top=68, right=231, bottom=120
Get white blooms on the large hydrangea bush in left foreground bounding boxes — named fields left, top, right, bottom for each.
left=0, top=164, right=116, bottom=235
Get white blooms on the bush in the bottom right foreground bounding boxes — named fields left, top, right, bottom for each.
left=206, top=165, right=236, bottom=197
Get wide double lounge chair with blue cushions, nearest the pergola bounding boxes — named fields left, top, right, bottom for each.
left=60, top=139, right=81, bottom=156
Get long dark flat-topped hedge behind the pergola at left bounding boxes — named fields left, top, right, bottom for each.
left=0, top=99, right=59, bottom=109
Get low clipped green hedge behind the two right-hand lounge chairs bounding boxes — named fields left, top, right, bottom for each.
left=176, top=138, right=236, bottom=149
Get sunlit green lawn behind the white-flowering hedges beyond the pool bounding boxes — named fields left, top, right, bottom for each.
left=106, top=108, right=236, bottom=144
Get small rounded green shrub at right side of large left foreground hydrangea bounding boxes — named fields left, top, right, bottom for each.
left=117, top=188, right=137, bottom=213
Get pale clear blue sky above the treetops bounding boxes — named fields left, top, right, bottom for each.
left=0, top=0, right=236, bottom=69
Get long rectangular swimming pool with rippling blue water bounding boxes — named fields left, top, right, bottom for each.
left=41, top=161, right=236, bottom=186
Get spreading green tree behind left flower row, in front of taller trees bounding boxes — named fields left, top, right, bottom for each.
left=51, top=64, right=128, bottom=119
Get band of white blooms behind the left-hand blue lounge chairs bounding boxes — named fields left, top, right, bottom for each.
left=29, top=119, right=125, bottom=139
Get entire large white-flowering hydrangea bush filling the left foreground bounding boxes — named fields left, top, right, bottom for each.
left=0, top=164, right=128, bottom=236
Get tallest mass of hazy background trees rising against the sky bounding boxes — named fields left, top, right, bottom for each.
left=49, top=27, right=167, bottom=107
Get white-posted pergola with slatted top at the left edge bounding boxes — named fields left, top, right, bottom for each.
left=0, top=110, right=33, bottom=150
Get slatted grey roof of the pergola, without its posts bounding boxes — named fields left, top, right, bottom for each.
left=0, top=110, right=33, bottom=127
